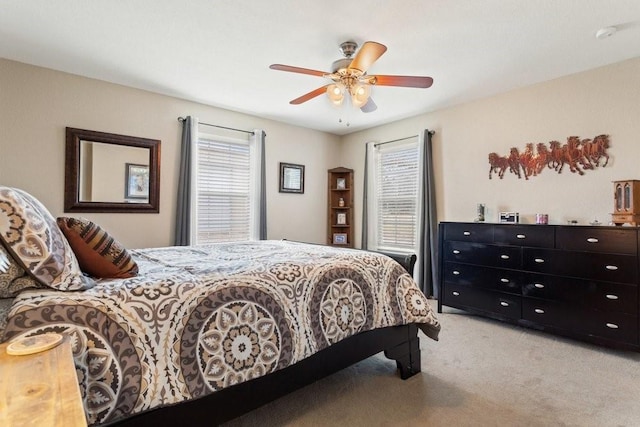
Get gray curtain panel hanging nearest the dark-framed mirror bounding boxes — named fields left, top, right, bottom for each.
left=174, top=116, right=197, bottom=246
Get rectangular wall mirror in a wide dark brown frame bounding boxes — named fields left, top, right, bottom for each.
left=64, top=127, right=160, bottom=213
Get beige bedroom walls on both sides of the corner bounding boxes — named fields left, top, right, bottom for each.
left=0, top=58, right=640, bottom=251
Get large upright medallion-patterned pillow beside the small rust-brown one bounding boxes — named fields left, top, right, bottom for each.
left=0, top=186, right=95, bottom=291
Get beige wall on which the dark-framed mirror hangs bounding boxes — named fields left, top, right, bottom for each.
left=0, top=59, right=339, bottom=248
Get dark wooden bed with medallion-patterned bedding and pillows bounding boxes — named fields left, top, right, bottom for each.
left=0, top=187, right=440, bottom=426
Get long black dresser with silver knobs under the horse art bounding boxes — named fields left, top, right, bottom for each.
left=438, top=222, right=640, bottom=350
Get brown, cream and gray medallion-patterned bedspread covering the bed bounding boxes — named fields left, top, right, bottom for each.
left=4, top=241, right=440, bottom=424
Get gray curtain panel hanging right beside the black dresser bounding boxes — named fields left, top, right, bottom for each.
left=418, top=129, right=438, bottom=298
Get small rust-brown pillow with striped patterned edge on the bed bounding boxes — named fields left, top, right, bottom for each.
left=58, top=217, right=138, bottom=278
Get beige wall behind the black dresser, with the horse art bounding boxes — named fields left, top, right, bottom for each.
left=341, top=58, right=640, bottom=245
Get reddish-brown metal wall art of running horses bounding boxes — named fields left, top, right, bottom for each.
left=489, top=135, right=609, bottom=179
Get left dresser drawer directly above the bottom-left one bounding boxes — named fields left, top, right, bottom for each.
left=444, top=262, right=522, bottom=295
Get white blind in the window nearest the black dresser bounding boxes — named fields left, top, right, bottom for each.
left=375, top=141, right=419, bottom=251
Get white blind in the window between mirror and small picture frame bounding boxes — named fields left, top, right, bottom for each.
left=196, top=136, right=252, bottom=244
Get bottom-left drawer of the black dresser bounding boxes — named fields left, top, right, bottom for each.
left=442, top=284, right=522, bottom=319
